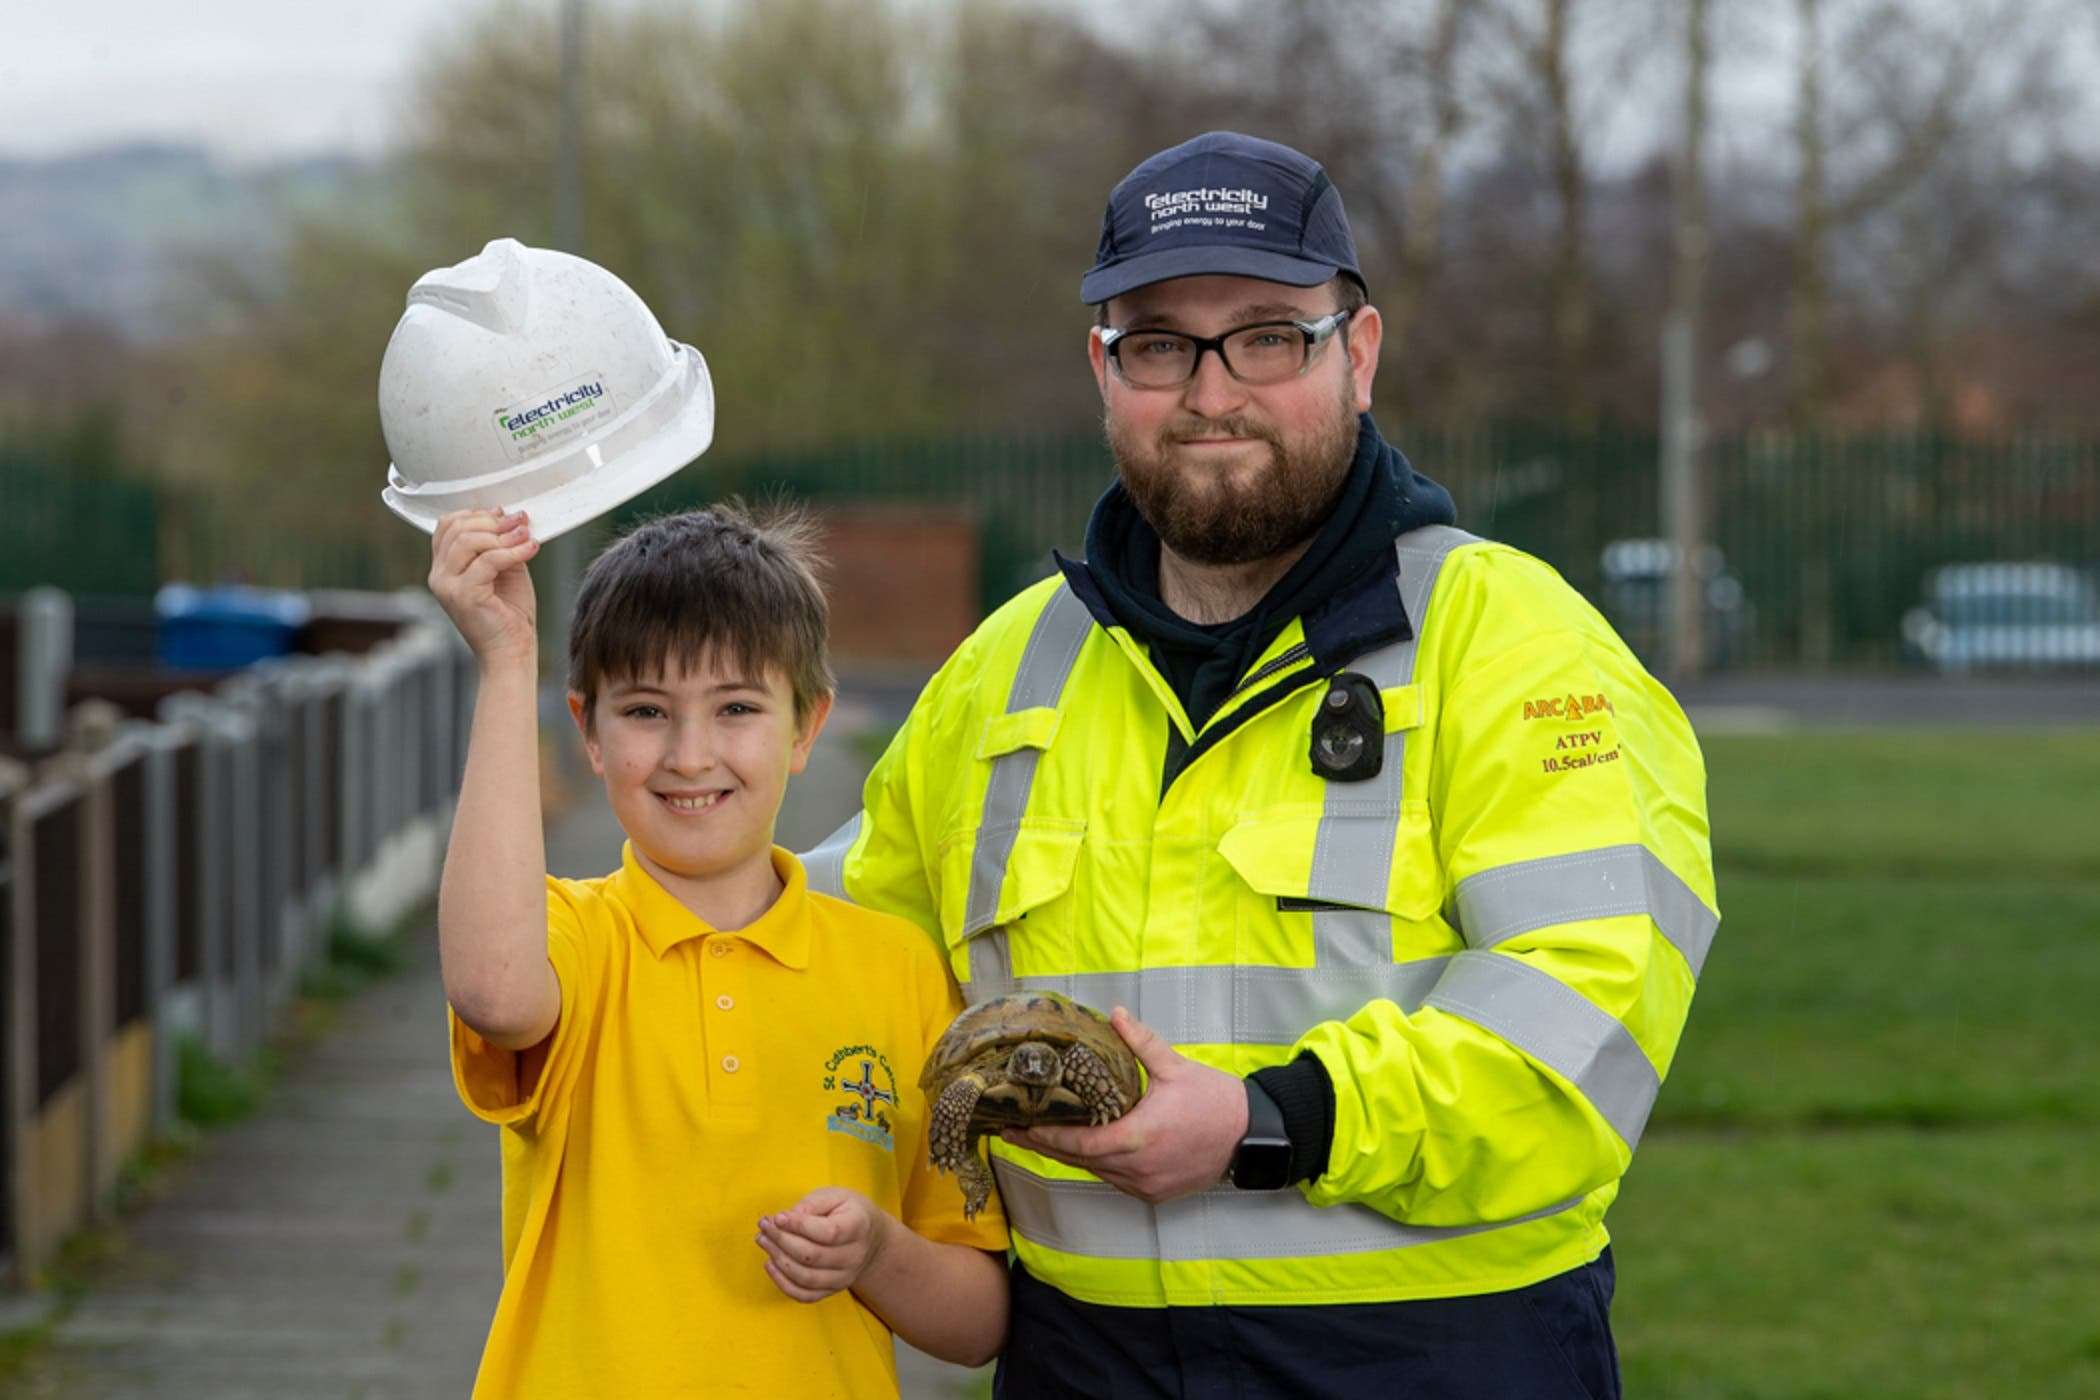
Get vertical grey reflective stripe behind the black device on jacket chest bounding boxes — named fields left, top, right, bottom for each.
left=1308, top=525, right=1474, bottom=948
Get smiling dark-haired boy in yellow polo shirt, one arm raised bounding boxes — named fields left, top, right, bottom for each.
left=431, top=508, right=1006, bottom=1398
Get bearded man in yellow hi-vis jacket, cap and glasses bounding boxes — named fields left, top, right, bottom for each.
left=811, top=132, right=1718, bottom=1400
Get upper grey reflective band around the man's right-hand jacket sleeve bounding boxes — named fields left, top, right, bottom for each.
left=1457, top=844, right=1720, bottom=976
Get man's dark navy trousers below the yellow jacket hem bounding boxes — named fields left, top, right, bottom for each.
left=991, top=1249, right=1619, bottom=1400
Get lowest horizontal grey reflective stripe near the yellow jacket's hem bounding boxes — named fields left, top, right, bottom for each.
left=991, top=1159, right=1581, bottom=1264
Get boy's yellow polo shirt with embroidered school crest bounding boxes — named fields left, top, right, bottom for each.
left=452, top=848, right=1006, bottom=1400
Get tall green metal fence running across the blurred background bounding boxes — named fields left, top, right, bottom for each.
left=0, top=424, right=2100, bottom=670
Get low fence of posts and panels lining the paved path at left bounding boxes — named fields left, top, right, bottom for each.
left=0, top=619, right=473, bottom=1285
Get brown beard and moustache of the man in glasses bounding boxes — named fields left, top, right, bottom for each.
left=1105, top=380, right=1357, bottom=565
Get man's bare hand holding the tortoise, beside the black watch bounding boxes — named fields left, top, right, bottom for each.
left=1002, top=1007, right=1247, bottom=1205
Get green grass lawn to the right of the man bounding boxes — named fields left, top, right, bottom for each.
left=1611, top=730, right=2100, bottom=1400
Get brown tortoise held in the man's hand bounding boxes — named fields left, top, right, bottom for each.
left=920, top=991, right=1142, bottom=1219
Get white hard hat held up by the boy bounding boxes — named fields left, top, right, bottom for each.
left=380, top=237, right=714, bottom=539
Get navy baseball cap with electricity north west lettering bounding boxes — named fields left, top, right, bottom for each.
left=1079, top=132, right=1363, bottom=306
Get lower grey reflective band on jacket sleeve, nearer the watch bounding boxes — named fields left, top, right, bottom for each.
left=1424, top=951, right=1663, bottom=1148
